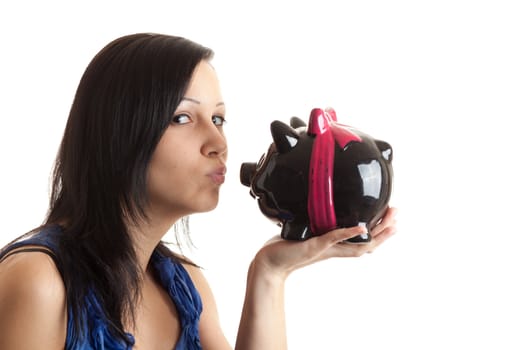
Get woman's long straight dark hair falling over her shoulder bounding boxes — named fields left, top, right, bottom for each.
left=44, top=33, right=213, bottom=340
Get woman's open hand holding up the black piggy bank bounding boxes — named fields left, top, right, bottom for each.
left=254, top=208, right=396, bottom=279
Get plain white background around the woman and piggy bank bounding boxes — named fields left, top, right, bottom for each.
left=0, top=0, right=525, bottom=350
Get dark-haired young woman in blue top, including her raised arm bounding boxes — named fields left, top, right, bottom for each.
left=0, top=34, right=395, bottom=350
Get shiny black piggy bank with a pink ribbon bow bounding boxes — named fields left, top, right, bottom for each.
left=240, top=108, right=393, bottom=243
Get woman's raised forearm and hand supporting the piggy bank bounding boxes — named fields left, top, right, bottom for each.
left=235, top=208, right=395, bottom=350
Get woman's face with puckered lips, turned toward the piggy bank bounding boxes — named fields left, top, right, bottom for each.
left=148, top=61, right=227, bottom=218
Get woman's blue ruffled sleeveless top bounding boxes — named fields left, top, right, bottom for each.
left=0, top=226, right=202, bottom=350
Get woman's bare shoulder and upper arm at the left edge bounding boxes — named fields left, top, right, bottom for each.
left=0, top=247, right=67, bottom=349
